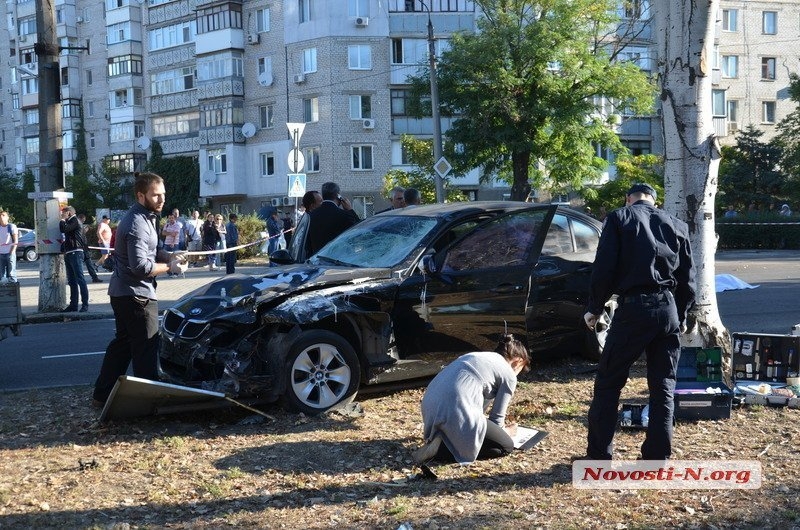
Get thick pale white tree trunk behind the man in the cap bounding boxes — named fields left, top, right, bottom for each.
left=651, top=0, right=731, bottom=380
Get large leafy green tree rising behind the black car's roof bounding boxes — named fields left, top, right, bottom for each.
left=412, top=0, right=654, bottom=200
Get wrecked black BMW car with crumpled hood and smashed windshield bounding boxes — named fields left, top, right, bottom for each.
left=160, top=202, right=613, bottom=414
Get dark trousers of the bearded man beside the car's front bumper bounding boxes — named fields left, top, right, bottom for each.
left=94, top=296, right=158, bottom=401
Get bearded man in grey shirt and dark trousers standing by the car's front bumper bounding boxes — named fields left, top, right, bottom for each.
left=92, top=172, right=186, bottom=407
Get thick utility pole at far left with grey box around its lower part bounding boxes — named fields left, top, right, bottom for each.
left=29, top=0, right=72, bottom=312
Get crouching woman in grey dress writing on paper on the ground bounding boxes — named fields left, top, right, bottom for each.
left=412, top=335, right=530, bottom=464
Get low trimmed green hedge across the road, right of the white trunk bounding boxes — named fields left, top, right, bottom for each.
left=716, top=215, right=800, bottom=249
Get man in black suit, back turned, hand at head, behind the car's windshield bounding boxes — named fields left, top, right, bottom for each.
left=306, top=182, right=361, bottom=257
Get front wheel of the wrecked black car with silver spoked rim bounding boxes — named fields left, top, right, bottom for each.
left=284, top=330, right=361, bottom=415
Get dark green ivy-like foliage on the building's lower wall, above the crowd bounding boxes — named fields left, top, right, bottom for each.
left=147, top=141, right=200, bottom=212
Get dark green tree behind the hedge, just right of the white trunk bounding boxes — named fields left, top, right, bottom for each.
left=717, top=125, right=786, bottom=212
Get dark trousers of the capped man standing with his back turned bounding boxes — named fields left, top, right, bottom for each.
left=587, top=291, right=680, bottom=460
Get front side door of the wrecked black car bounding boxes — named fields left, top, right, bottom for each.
left=394, top=207, right=555, bottom=361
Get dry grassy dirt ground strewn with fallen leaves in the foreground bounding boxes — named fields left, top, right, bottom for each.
left=0, top=359, right=800, bottom=530
